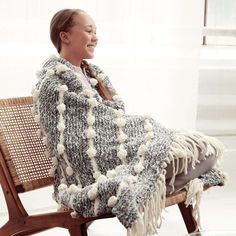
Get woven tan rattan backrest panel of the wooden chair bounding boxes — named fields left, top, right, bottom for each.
left=0, top=97, right=52, bottom=191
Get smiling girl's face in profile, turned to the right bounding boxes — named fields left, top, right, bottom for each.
left=61, top=12, right=98, bottom=59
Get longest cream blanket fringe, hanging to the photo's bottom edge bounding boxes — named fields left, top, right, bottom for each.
left=127, top=179, right=166, bottom=236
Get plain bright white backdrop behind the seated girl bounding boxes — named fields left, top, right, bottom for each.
left=0, top=0, right=203, bottom=218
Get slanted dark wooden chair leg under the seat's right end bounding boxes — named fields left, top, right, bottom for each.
left=178, top=202, right=199, bottom=233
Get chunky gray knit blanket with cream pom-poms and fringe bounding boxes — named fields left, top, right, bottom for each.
left=32, top=56, right=227, bottom=236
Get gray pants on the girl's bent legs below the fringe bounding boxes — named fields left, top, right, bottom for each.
left=166, top=155, right=216, bottom=195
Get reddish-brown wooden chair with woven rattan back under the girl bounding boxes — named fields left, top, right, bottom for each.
left=0, top=97, right=203, bottom=236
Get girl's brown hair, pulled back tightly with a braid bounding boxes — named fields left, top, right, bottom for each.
left=50, top=9, right=95, bottom=78
